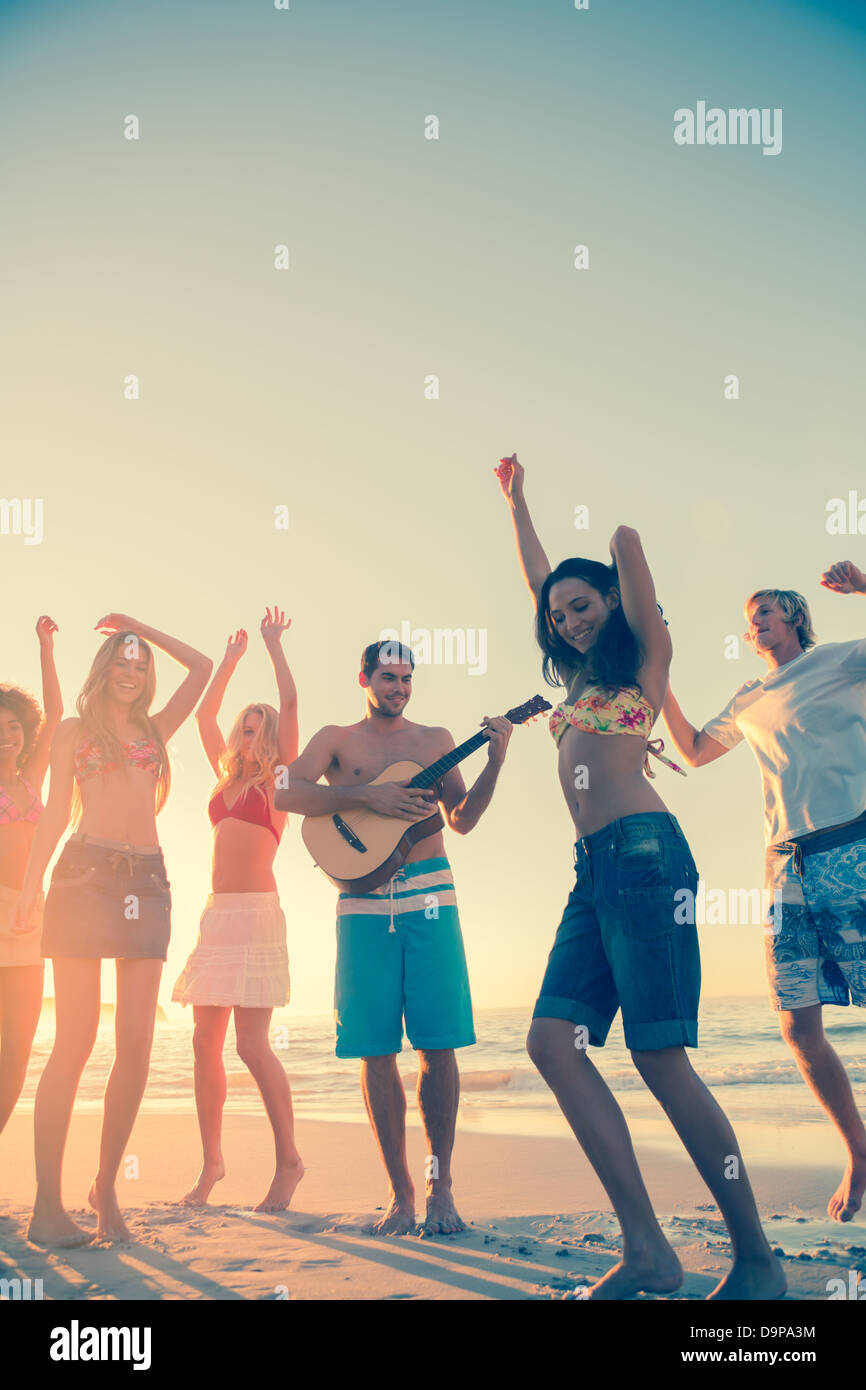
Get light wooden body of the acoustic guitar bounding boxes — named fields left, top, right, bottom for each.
left=300, top=762, right=442, bottom=892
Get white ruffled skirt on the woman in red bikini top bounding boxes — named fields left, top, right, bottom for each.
left=171, top=892, right=289, bottom=1009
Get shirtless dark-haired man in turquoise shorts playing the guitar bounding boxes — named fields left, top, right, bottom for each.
left=275, top=642, right=512, bottom=1236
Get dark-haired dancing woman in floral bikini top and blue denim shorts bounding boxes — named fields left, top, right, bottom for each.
left=496, top=455, right=785, bottom=1298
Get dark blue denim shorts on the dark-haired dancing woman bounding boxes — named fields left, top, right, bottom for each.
left=532, top=812, right=701, bottom=1052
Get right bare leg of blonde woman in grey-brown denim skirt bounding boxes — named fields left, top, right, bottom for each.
left=88, top=960, right=163, bottom=1240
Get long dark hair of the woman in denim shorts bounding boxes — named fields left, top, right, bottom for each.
left=535, top=559, right=642, bottom=689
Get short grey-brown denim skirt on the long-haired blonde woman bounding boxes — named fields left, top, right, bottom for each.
left=42, top=834, right=171, bottom=960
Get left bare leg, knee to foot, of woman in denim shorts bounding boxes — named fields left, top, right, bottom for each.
left=527, top=1019, right=683, bottom=1298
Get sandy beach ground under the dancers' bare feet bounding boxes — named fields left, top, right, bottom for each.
left=0, top=1112, right=866, bottom=1300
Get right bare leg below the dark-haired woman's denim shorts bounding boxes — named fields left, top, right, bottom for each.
left=631, top=1047, right=785, bottom=1298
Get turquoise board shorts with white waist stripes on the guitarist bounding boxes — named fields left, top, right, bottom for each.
left=334, top=858, right=475, bottom=1056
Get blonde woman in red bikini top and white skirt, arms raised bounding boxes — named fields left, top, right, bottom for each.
left=172, top=607, right=303, bottom=1211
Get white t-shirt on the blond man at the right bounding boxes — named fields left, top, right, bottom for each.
left=703, top=638, right=866, bottom=845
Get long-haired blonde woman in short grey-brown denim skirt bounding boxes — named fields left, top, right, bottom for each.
left=15, top=613, right=213, bottom=1247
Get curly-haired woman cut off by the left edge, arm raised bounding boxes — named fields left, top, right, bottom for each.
left=0, top=617, right=63, bottom=1130
